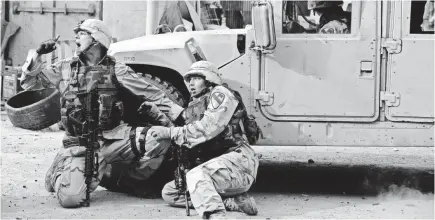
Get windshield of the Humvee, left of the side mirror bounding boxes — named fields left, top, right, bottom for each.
left=200, top=0, right=252, bottom=30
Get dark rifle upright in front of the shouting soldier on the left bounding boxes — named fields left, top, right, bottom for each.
left=77, top=90, right=101, bottom=207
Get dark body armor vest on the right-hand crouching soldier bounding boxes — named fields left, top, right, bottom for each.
left=182, top=89, right=243, bottom=162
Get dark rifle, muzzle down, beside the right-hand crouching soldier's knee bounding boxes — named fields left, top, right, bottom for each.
left=173, top=142, right=191, bottom=216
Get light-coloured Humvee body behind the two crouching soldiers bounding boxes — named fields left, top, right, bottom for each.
left=109, top=1, right=434, bottom=146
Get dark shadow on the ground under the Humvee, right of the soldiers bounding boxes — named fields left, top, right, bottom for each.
left=251, top=160, right=434, bottom=195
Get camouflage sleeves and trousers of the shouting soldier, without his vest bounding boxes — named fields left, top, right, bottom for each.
left=20, top=19, right=182, bottom=207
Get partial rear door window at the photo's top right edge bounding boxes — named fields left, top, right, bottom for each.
left=410, top=0, right=434, bottom=34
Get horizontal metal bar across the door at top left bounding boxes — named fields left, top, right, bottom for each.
left=12, top=2, right=97, bottom=16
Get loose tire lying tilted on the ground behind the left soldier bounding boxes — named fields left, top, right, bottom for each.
left=6, top=88, right=60, bottom=130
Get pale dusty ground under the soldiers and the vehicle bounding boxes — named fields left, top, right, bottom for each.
left=1, top=115, right=434, bottom=219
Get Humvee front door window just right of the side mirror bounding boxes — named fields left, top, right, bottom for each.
left=282, top=0, right=352, bottom=34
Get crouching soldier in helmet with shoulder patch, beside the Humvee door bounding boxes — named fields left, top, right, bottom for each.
left=153, top=61, right=259, bottom=218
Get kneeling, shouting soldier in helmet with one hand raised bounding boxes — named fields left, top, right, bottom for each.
left=20, top=19, right=182, bottom=208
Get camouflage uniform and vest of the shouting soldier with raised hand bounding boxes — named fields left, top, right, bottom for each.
left=20, top=19, right=182, bottom=207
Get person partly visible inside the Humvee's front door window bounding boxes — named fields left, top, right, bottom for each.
left=307, top=0, right=351, bottom=34
